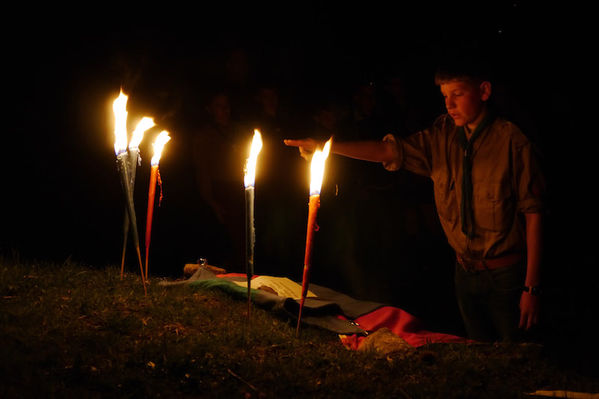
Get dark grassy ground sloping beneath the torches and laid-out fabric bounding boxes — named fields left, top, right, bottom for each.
left=0, top=258, right=599, bottom=398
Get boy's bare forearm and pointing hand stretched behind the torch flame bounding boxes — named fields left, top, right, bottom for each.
left=284, top=138, right=397, bottom=162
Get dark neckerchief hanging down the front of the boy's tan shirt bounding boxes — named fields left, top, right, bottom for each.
left=458, top=112, right=495, bottom=238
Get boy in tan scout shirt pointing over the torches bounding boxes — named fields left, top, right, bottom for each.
left=285, top=61, right=543, bottom=341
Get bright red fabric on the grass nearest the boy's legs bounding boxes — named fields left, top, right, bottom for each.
left=339, top=306, right=471, bottom=350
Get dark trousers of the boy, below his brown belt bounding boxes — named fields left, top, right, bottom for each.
left=455, top=262, right=526, bottom=342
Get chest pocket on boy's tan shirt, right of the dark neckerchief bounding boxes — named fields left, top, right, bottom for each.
left=473, top=183, right=515, bottom=232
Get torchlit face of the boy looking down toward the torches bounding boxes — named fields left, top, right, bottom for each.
left=440, top=80, right=491, bottom=126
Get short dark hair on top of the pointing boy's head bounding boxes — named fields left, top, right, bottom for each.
left=435, top=55, right=492, bottom=86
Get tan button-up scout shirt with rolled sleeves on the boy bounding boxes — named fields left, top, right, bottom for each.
left=383, top=115, right=544, bottom=260
